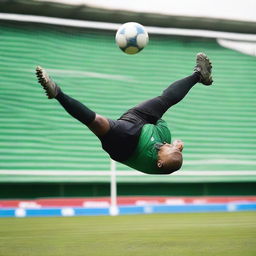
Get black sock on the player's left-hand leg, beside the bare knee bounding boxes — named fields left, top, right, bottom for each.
left=55, top=90, right=96, bottom=125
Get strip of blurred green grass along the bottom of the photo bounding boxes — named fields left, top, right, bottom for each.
left=0, top=212, right=256, bottom=256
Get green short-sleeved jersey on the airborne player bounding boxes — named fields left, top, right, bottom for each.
left=122, top=119, right=171, bottom=174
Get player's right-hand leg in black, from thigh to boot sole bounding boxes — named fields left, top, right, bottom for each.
left=128, top=53, right=213, bottom=123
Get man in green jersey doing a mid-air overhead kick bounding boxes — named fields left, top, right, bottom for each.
left=36, top=53, right=213, bottom=174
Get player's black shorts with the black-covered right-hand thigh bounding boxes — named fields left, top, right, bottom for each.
left=100, top=97, right=168, bottom=162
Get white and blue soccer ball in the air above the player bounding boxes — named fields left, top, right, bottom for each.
left=116, top=22, right=148, bottom=54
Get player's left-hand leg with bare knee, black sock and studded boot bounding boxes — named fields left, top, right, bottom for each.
left=36, top=67, right=110, bottom=136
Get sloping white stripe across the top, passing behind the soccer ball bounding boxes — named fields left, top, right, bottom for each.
left=0, top=13, right=256, bottom=42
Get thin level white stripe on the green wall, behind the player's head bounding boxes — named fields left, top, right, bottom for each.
left=0, top=170, right=256, bottom=176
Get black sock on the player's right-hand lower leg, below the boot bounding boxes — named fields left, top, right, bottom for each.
left=160, top=72, right=200, bottom=108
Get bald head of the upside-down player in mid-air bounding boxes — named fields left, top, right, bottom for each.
left=157, top=140, right=184, bottom=173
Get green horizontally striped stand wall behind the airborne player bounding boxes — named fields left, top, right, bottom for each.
left=0, top=21, right=256, bottom=197
